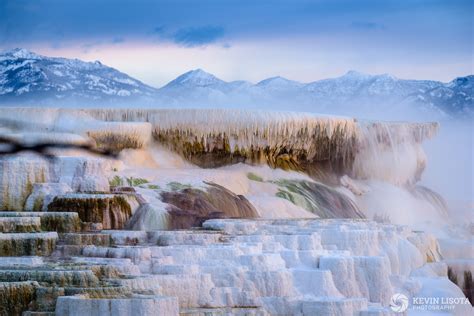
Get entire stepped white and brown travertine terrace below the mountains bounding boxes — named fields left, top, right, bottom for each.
left=0, top=108, right=473, bottom=316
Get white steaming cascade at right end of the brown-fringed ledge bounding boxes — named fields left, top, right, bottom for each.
left=348, top=122, right=447, bottom=224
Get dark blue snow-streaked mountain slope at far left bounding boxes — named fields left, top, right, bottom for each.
left=0, top=48, right=155, bottom=104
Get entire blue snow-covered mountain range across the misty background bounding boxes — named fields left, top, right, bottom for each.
left=0, top=48, right=474, bottom=119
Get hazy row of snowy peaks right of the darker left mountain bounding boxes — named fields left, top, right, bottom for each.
left=158, top=69, right=474, bottom=119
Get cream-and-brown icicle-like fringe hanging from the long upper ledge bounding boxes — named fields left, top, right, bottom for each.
left=88, top=109, right=357, bottom=164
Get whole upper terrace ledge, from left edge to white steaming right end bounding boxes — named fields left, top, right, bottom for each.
left=0, top=108, right=437, bottom=178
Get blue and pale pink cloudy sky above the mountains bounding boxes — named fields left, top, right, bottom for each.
left=0, top=0, right=474, bottom=87
